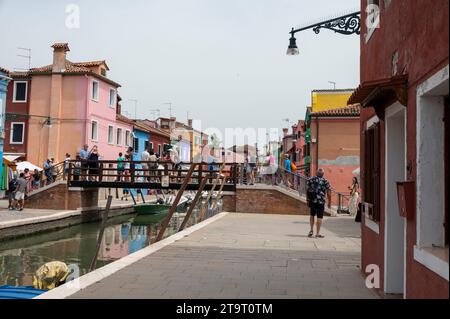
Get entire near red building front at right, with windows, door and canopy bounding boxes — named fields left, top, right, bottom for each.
left=349, top=0, right=450, bottom=298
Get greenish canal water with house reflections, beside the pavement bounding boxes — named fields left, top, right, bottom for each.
left=0, top=200, right=220, bottom=286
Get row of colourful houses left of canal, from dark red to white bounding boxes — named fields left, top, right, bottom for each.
left=0, top=43, right=208, bottom=186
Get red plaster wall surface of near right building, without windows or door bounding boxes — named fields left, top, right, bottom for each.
left=361, top=0, right=449, bottom=298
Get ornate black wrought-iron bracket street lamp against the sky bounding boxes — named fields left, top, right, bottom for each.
left=286, top=11, right=361, bottom=55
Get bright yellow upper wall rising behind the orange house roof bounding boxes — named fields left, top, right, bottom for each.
left=311, top=89, right=354, bottom=113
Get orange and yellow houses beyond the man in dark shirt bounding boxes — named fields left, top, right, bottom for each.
left=282, top=89, right=360, bottom=199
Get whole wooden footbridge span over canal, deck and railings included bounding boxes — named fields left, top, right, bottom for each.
left=67, top=160, right=239, bottom=191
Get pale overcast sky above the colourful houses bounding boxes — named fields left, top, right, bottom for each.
left=0, top=0, right=359, bottom=146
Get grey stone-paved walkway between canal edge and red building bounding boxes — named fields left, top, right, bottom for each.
left=71, top=213, right=379, bottom=299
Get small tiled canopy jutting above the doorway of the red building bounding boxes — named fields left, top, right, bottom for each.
left=347, top=74, right=408, bottom=109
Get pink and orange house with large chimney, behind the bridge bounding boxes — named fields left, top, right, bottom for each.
left=27, top=43, right=133, bottom=165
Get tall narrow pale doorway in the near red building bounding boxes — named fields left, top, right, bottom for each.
left=384, top=103, right=406, bottom=294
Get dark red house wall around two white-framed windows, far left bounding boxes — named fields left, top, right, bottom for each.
left=3, top=77, right=30, bottom=160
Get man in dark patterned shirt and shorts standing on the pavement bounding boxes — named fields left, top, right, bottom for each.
left=307, top=168, right=331, bottom=238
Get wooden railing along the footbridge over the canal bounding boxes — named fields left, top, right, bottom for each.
left=67, top=160, right=241, bottom=188
